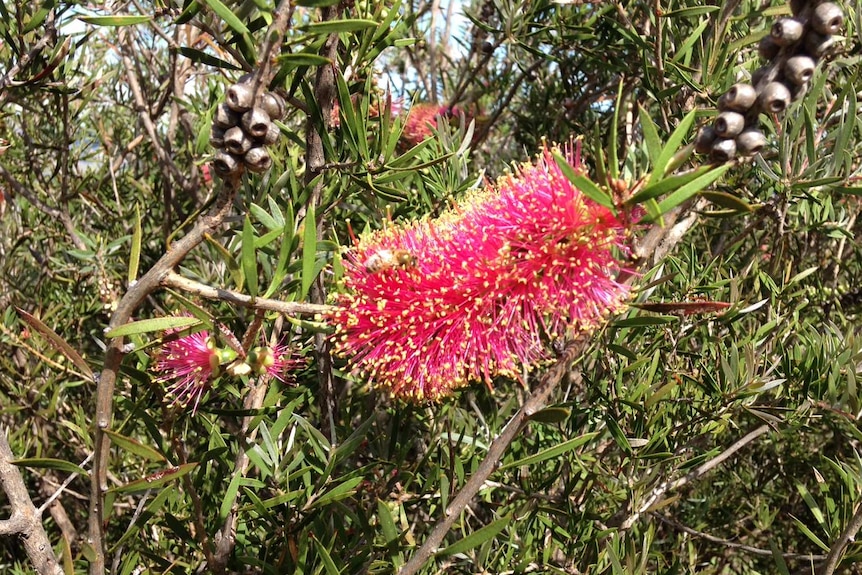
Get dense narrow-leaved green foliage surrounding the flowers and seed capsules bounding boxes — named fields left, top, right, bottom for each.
left=0, top=0, right=862, bottom=573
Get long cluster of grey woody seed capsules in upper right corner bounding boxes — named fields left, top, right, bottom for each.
left=695, top=0, right=844, bottom=162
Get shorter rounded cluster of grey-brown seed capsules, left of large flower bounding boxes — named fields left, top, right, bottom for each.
left=210, top=74, right=285, bottom=178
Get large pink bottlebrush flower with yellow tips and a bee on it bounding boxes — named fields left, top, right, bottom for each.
left=331, top=144, right=628, bottom=401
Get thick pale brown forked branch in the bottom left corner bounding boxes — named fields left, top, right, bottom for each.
left=0, top=430, right=63, bottom=575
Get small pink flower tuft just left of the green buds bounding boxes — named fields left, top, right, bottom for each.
left=155, top=331, right=224, bottom=413
